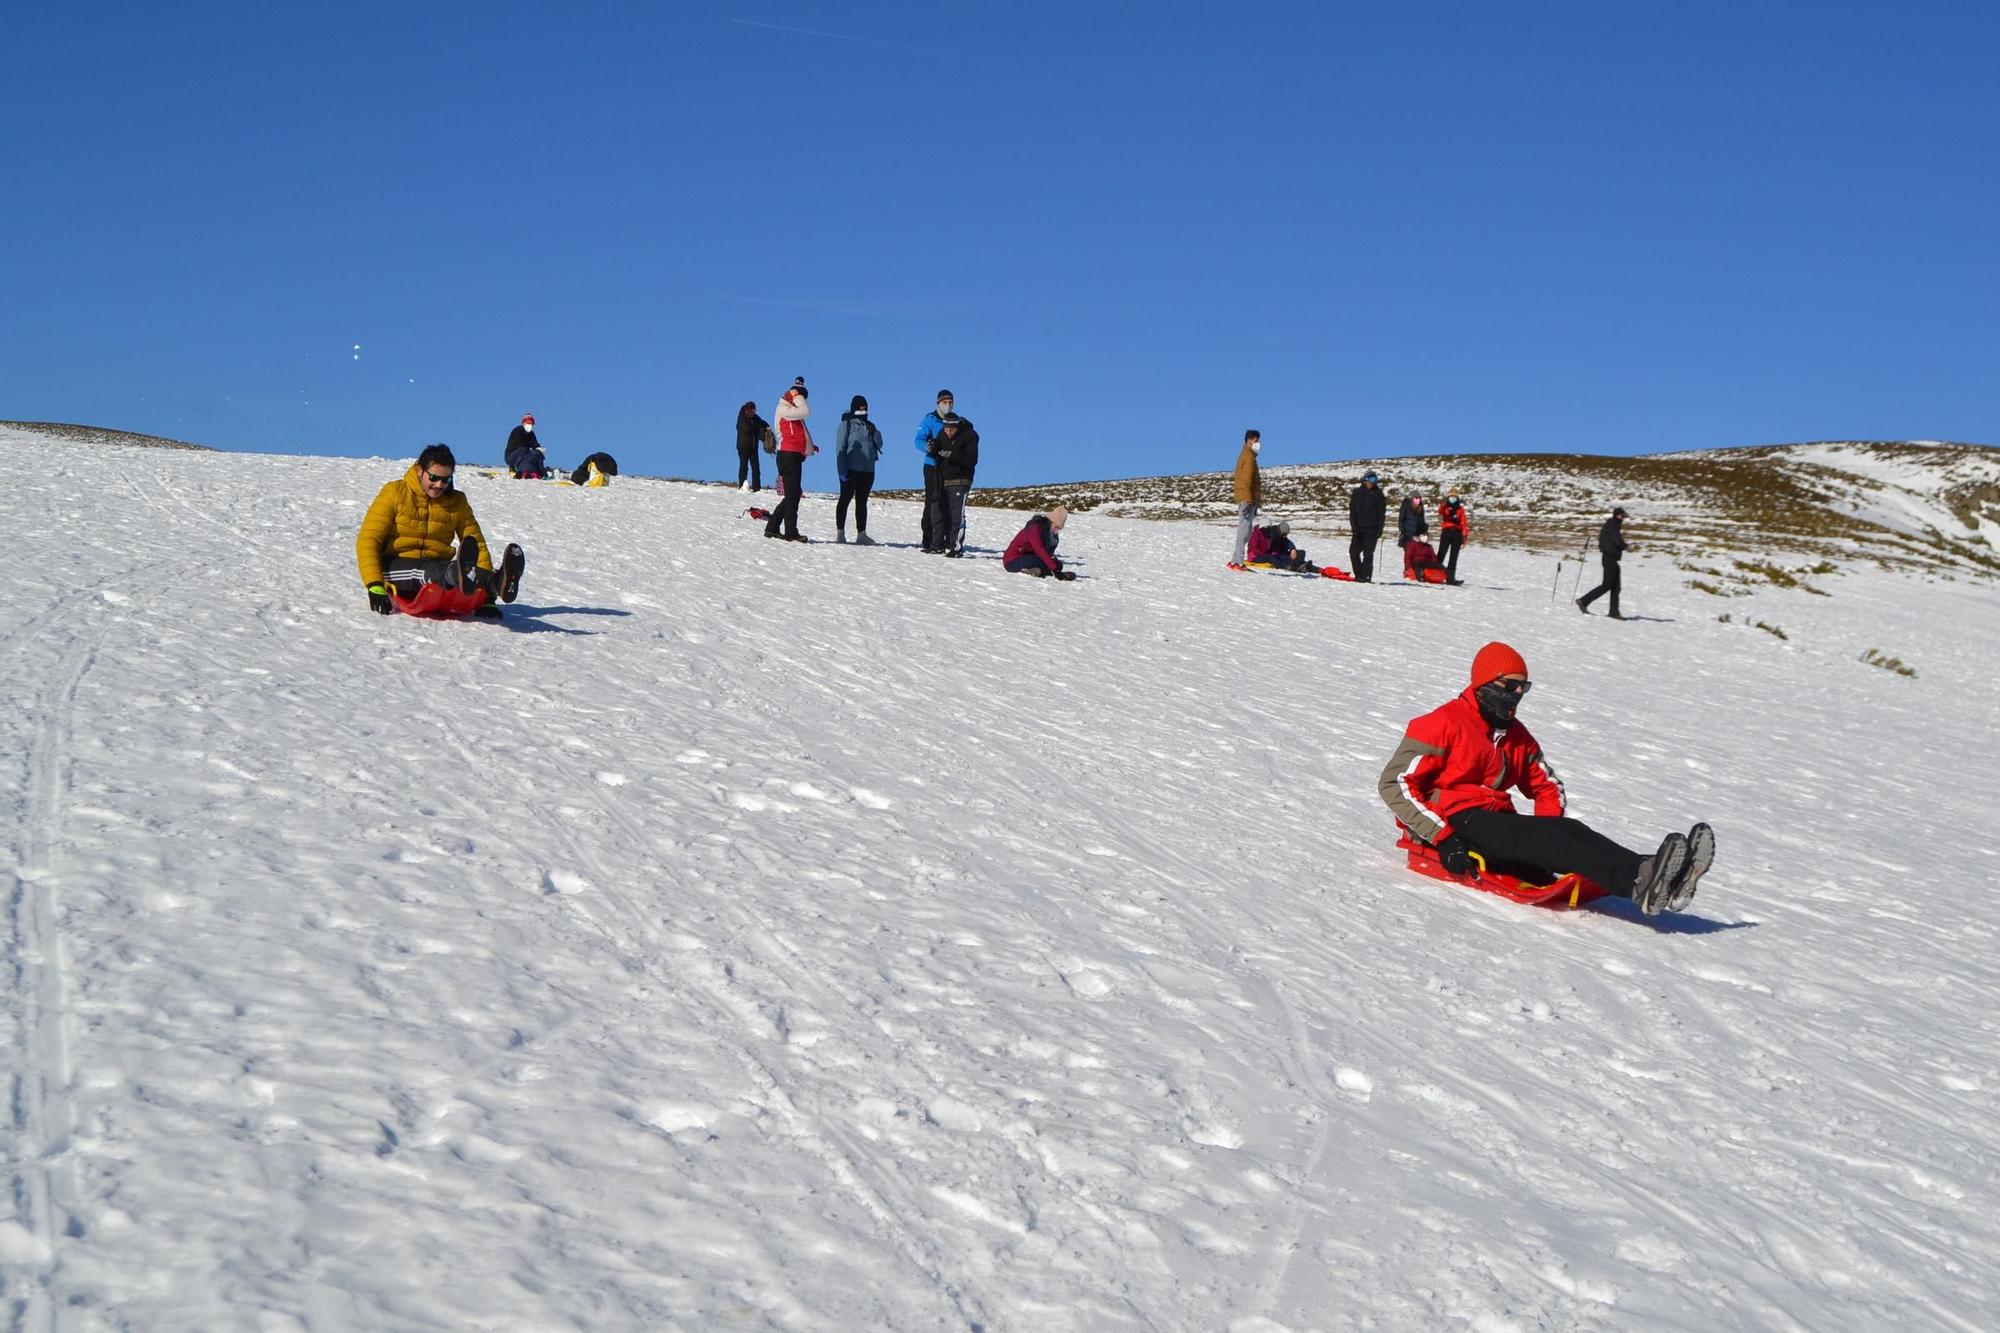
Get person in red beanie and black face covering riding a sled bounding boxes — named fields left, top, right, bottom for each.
left=1378, top=642, right=1716, bottom=917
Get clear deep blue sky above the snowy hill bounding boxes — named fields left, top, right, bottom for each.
left=0, top=0, right=2000, bottom=486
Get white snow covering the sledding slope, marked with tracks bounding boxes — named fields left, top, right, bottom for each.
left=0, top=432, right=2000, bottom=1333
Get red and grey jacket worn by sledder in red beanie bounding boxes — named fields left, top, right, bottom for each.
left=1378, top=687, right=1568, bottom=843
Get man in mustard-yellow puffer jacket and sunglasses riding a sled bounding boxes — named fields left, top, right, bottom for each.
left=354, top=444, right=526, bottom=616
